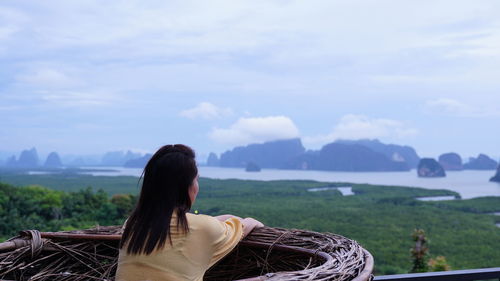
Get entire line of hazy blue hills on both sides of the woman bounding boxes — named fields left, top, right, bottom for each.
left=0, top=138, right=499, bottom=172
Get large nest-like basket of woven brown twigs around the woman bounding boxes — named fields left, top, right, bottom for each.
left=0, top=226, right=374, bottom=281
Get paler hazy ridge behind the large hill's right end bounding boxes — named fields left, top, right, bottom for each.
left=335, top=139, right=420, bottom=169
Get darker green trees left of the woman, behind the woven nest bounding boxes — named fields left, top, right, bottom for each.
left=0, top=180, right=135, bottom=237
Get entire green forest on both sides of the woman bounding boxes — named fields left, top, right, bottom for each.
left=0, top=174, right=500, bottom=274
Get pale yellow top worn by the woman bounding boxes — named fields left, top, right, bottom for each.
left=116, top=213, right=243, bottom=281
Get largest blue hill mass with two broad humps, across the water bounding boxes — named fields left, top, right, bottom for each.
left=208, top=138, right=420, bottom=172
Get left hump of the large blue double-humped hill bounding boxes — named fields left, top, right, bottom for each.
left=219, top=138, right=305, bottom=168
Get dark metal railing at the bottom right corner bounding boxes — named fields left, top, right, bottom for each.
left=373, top=267, right=500, bottom=281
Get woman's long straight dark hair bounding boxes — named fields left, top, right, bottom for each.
left=120, top=144, right=198, bottom=255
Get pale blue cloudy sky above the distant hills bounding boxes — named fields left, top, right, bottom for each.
left=0, top=0, right=500, bottom=162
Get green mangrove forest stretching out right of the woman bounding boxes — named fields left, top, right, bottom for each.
left=194, top=179, right=500, bottom=274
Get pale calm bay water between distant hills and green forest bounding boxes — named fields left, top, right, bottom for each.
left=79, top=166, right=500, bottom=199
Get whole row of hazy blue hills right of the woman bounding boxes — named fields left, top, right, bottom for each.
left=207, top=138, right=498, bottom=173
